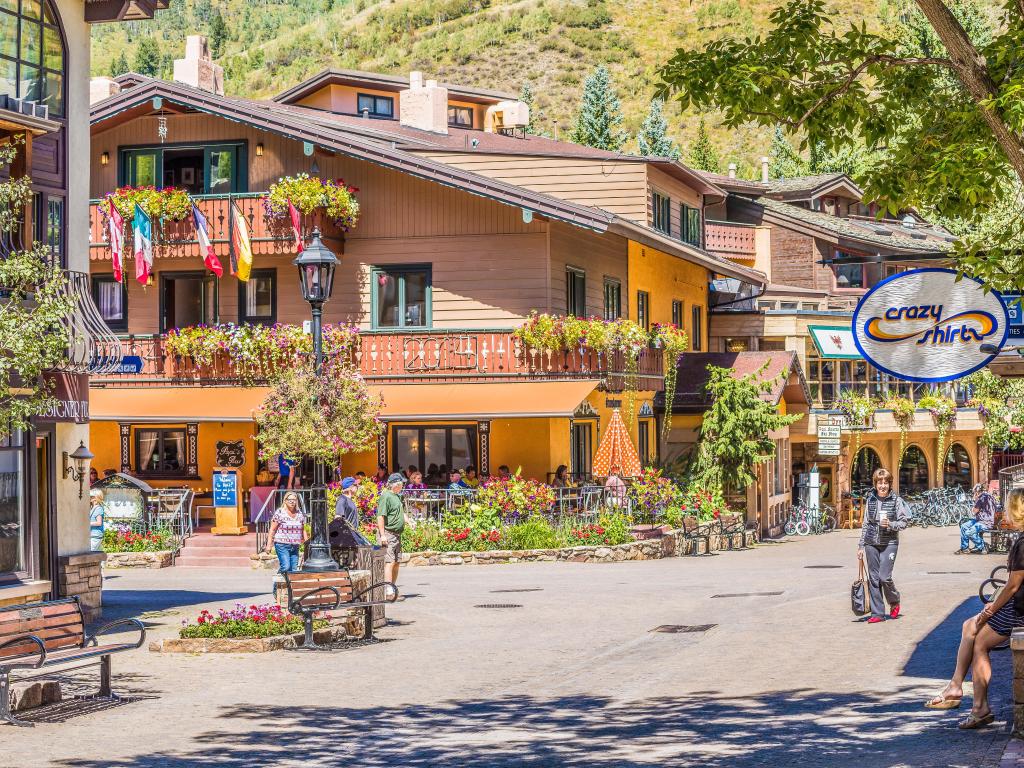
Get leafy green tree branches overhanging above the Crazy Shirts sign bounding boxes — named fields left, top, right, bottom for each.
left=660, top=0, right=1024, bottom=290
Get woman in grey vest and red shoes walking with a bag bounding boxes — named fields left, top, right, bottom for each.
left=857, top=467, right=910, bottom=624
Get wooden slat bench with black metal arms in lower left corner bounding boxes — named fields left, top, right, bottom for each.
left=0, top=597, right=145, bottom=725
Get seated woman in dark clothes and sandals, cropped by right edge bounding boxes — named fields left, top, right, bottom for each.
left=925, top=488, right=1024, bottom=730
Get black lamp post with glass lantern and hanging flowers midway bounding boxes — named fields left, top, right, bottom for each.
left=292, top=228, right=338, bottom=570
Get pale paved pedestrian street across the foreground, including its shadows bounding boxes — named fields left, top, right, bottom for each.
left=0, top=528, right=1011, bottom=768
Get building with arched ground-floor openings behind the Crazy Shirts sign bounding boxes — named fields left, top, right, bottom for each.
left=705, top=164, right=988, bottom=514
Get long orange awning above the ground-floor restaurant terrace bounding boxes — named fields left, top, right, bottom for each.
left=89, top=379, right=598, bottom=424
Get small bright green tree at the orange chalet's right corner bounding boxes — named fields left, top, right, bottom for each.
left=691, top=364, right=803, bottom=490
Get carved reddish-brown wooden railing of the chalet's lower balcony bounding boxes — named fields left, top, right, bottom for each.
left=91, top=330, right=664, bottom=391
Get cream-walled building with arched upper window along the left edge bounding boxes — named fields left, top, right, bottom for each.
left=0, top=0, right=166, bottom=615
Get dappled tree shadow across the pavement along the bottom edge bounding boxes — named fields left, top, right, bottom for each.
left=51, top=688, right=1009, bottom=768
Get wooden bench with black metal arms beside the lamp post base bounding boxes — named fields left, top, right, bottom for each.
left=285, top=570, right=398, bottom=650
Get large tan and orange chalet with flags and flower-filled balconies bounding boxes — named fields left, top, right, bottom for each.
left=83, top=38, right=765, bottom=518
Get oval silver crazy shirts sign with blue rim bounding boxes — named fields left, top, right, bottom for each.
left=853, top=268, right=1010, bottom=382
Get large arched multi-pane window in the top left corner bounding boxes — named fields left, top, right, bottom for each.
left=0, top=0, right=65, bottom=117
